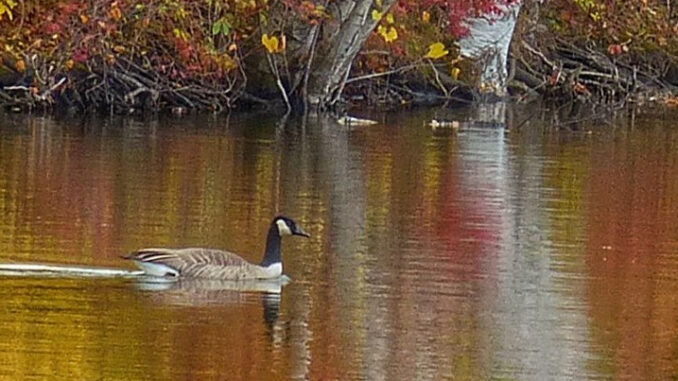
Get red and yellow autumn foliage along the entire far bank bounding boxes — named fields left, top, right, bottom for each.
left=0, top=0, right=678, bottom=110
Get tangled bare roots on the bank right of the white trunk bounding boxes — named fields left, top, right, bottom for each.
left=512, top=37, right=678, bottom=103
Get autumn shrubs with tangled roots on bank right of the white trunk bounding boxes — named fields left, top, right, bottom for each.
left=514, top=0, right=678, bottom=104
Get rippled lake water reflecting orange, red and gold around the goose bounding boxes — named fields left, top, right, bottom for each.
left=0, top=104, right=678, bottom=380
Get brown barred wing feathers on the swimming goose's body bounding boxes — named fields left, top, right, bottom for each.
left=126, top=248, right=254, bottom=277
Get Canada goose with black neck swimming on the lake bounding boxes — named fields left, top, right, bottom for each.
left=123, top=216, right=310, bottom=280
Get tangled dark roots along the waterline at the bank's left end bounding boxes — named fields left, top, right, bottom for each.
left=0, top=57, right=250, bottom=113
